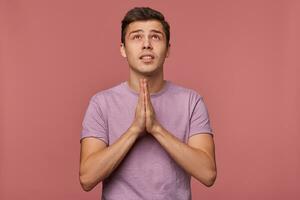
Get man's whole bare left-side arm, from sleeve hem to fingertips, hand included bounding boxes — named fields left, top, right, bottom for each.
left=80, top=79, right=146, bottom=191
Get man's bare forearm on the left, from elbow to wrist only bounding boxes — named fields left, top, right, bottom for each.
left=81, top=128, right=139, bottom=190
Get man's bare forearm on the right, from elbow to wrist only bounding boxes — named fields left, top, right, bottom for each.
left=152, top=127, right=216, bottom=186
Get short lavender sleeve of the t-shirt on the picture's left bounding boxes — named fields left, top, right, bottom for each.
left=80, top=95, right=108, bottom=144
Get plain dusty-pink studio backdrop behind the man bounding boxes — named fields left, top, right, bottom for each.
left=0, top=0, right=300, bottom=200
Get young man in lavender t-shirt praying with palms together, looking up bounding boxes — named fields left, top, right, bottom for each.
left=80, top=8, right=217, bottom=200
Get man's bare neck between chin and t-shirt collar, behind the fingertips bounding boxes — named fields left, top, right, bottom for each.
left=128, top=71, right=165, bottom=94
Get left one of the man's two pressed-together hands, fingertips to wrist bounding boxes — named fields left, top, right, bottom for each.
left=130, top=79, right=146, bottom=135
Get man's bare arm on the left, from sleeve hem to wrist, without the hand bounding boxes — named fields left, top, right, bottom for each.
left=80, top=128, right=139, bottom=191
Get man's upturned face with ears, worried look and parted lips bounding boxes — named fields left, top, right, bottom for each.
left=121, top=20, right=169, bottom=75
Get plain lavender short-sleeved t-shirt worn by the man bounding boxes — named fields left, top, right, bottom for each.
left=80, top=80, right=213, bottom=200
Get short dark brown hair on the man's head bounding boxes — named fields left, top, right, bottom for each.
left=121, top=7, right=170, bottom=46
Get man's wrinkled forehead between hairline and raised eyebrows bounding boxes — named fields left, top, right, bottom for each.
left=126, top=20, right=164, bottom=34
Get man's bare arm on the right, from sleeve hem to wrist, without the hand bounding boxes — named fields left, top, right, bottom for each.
left=152, top=126, right=217, bottom=187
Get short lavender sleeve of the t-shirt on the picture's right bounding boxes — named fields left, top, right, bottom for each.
left=189, top=93, right=213, bottom=137
